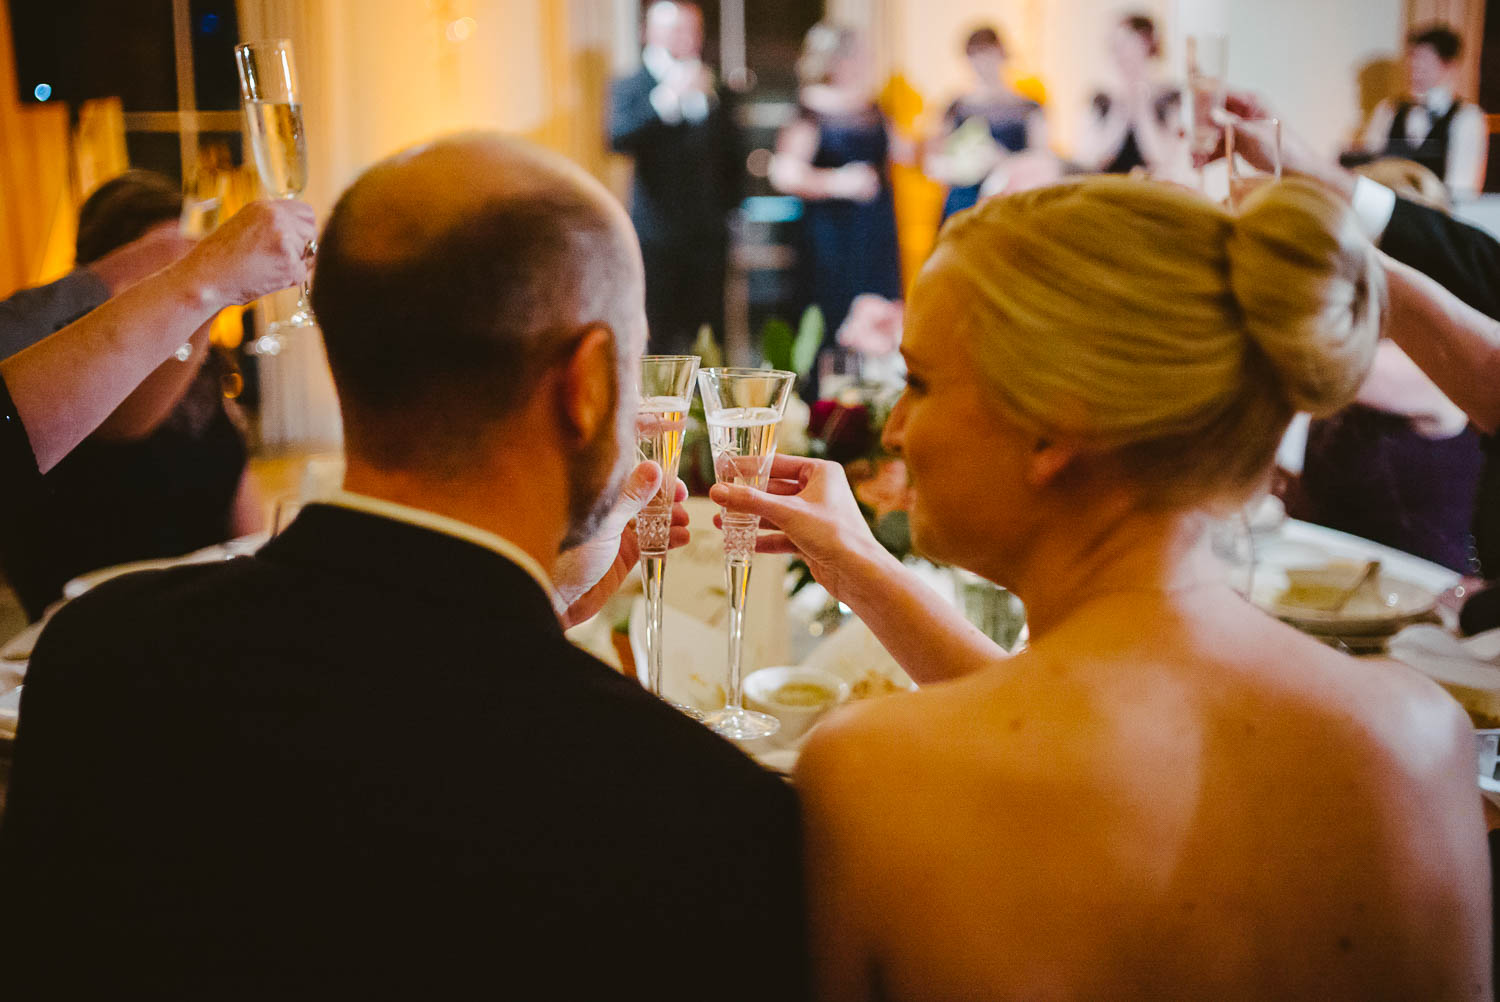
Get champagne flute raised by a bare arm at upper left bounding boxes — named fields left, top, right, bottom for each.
left=234, top=39, right=318, bottom=356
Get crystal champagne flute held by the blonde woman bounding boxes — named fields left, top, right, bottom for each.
left=698, top=369, right=797, bottom=741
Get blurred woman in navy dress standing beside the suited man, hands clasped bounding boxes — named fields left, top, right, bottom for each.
left=771, top=24, right=911, bottom=344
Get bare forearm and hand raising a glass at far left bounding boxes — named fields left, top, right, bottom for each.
left=0, top=201, right=317, bottom=473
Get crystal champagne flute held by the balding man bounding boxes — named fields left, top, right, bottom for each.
left=636, top=356, right=702, bottom=717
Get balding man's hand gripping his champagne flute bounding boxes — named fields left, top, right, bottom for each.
left=554, top=462, right=689, bottom=629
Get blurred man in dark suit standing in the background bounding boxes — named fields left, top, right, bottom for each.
left=609, top=0, right=740, bottom=354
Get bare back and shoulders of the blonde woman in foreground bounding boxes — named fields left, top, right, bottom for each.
left=798, top=590, right=1490, bottom=1001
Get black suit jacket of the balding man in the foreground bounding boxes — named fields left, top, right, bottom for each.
left=0, top=506, right=804, bottom=1001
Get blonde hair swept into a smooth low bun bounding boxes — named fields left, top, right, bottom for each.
left=933, top=177, right=1385, bottom=507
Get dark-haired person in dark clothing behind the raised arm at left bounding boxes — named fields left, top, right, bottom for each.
left=0, top=171, right=263, bottom=620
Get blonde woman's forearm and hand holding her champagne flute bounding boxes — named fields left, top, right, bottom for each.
left=710, top=456, right=1008, bottom=684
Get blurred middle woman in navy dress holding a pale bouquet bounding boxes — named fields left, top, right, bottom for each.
left=923, top=27, right=1047, bottom=219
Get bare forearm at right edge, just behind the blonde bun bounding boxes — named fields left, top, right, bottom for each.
left=1382, top=255, right=1500, bottom=435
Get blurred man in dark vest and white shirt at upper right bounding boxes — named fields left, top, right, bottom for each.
left=1364, top=26, right=1490, bottom=200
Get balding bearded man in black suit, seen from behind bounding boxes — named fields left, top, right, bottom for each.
left=0, top=137, right=804, bottom=999
